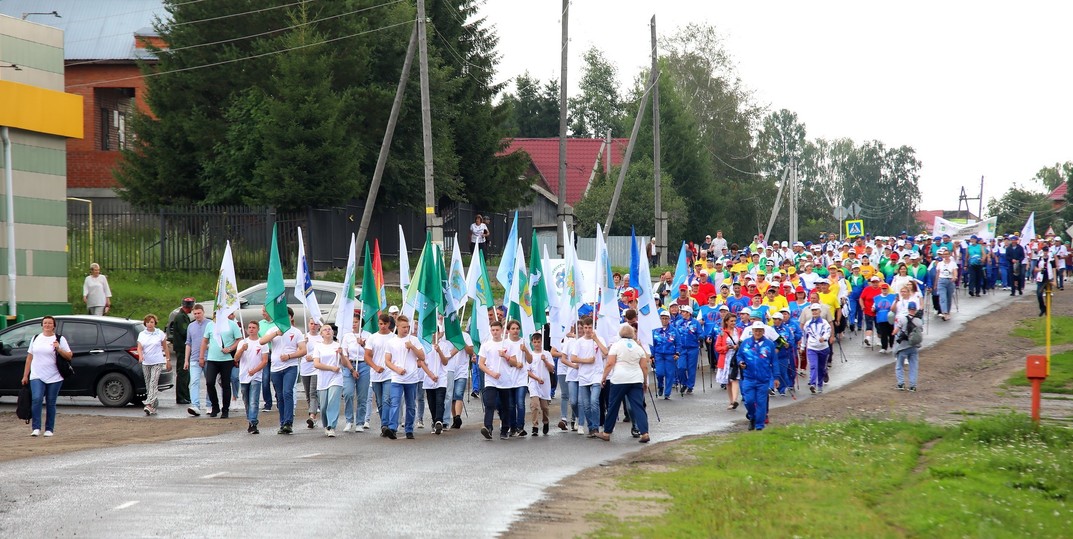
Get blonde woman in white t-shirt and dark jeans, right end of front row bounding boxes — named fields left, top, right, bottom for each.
left=596, top=325, right=651, bottom=443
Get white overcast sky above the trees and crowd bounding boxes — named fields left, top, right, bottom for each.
left=482, top=0, right=1073, bottom=212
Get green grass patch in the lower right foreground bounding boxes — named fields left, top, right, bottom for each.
left=591, top=414, right=1073, bottom=538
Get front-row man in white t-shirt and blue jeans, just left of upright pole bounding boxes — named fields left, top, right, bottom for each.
left=384, top=315, right=436, bottom=440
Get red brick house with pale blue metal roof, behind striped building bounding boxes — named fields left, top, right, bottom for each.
left=0, top=0, right=167, bottom=199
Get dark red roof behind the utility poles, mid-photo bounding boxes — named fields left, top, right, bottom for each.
left=503, top=137, right=630, bottom=206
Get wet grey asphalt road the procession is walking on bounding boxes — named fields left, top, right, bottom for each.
left=0, top=293, right=1009, bottom=538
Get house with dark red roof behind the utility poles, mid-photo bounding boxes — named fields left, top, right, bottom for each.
left=503, top=137, right=630, bottom=233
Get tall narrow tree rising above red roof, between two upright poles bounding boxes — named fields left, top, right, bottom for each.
left=556, top=47, right=629, bottom=139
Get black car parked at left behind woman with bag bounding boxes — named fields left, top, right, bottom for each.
left=0, top=315, right=175, bottom=407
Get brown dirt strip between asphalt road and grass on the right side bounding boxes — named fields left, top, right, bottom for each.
left=506, top=295, right=1073, bottom=538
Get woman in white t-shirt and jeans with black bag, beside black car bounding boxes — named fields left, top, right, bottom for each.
left=23, top=317, right=74, bottom=436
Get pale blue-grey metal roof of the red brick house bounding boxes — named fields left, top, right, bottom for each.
left=0, top=0, right=167, bottom=60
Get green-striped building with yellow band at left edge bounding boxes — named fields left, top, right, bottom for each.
left=0, top=13, right=84, bottom=315
